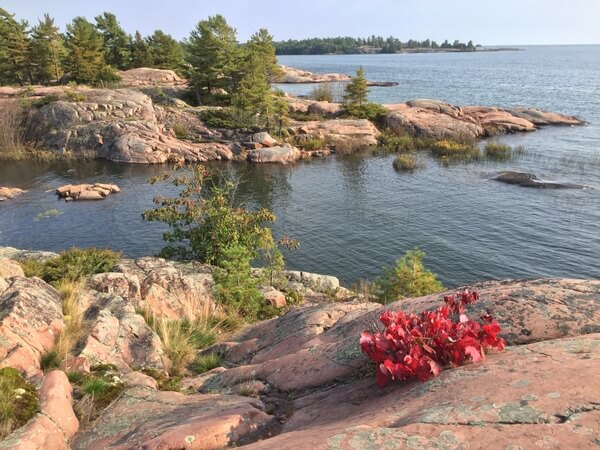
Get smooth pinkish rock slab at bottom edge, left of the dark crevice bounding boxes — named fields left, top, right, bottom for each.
left=72, top=387, right=274, bottom=450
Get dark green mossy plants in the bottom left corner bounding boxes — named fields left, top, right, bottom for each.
left=0, top=367, right=38, bottom=439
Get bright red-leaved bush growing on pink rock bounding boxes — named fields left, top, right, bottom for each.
left=360, top=290, right=506, bottom=387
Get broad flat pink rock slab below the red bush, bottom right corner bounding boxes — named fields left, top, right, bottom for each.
left=248, top=334, right=600, bottom=449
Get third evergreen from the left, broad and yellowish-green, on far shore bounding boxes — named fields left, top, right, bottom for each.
left=65, top=17, right=115, bottom=84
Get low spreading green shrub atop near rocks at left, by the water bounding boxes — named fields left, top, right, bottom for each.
left=43, top=248, right=121, bottom=283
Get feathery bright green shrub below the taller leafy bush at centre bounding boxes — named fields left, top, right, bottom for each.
left=213, top=244, right=278, bottom=322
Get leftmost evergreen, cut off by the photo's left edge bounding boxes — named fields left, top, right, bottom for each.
left=0, top=8, right=31, bottom=85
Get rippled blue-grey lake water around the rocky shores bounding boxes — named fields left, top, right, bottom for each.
left=0, top=46, right=600, bottom=286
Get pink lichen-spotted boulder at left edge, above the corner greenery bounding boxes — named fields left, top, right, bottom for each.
left=0, top=277, right=64, bottom=377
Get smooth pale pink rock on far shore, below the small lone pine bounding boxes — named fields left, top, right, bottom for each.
left=292, top=119, right=381, bottom=151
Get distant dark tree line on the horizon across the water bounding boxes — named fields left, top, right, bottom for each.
left=274, top=36, right=477, bottom=55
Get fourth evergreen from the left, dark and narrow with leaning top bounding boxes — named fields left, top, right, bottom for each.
left=95, top=12, right=131, bottom=70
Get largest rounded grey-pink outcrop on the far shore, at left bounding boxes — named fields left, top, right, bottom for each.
left=31, top=89, right=233, bottom=164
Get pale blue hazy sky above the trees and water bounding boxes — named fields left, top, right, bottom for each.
left=0, top=0, right=600, bottom=45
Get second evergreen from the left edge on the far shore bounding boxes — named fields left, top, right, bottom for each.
left=30, top=14, right=65, bottom=84
